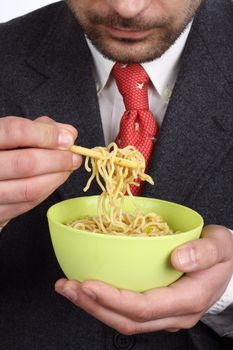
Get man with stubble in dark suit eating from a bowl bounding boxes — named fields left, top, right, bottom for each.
left=0, top=0, right=233, bottom=350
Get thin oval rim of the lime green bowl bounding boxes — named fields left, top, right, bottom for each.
left=47, top=195, right=204, bottom=241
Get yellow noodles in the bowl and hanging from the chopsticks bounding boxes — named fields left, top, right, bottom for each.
left=67, top=143, right=173, bottom=236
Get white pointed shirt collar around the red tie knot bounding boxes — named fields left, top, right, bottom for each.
left=86, top=21, right=192, bottom=99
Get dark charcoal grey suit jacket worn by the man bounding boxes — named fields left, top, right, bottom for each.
left=0, top=0, right=233, bottom=350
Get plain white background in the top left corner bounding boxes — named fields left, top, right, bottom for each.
left=0, top=0, right=58, bottom=22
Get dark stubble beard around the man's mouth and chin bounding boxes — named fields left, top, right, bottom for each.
left=67, top=0, right=203, bottom=64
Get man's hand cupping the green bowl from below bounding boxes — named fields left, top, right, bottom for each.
left=55, top=225, right=233, bottom=335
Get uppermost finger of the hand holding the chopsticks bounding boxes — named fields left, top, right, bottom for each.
left=0, top=116, right=75, bottom=149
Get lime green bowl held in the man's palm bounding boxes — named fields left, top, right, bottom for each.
left=47, top=196, right=203, bottom=292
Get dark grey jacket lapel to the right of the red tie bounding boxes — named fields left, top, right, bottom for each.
left=143, top=0, right=233, bottom=203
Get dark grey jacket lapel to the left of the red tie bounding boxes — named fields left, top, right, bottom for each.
left=22, top=4, right=104, bottom=198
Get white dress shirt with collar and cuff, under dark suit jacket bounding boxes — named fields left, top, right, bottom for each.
left=86, top=23, right=233, bottom=337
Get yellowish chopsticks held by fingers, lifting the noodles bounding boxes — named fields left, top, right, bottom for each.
left=70, top=145, right=144, bottom=169
